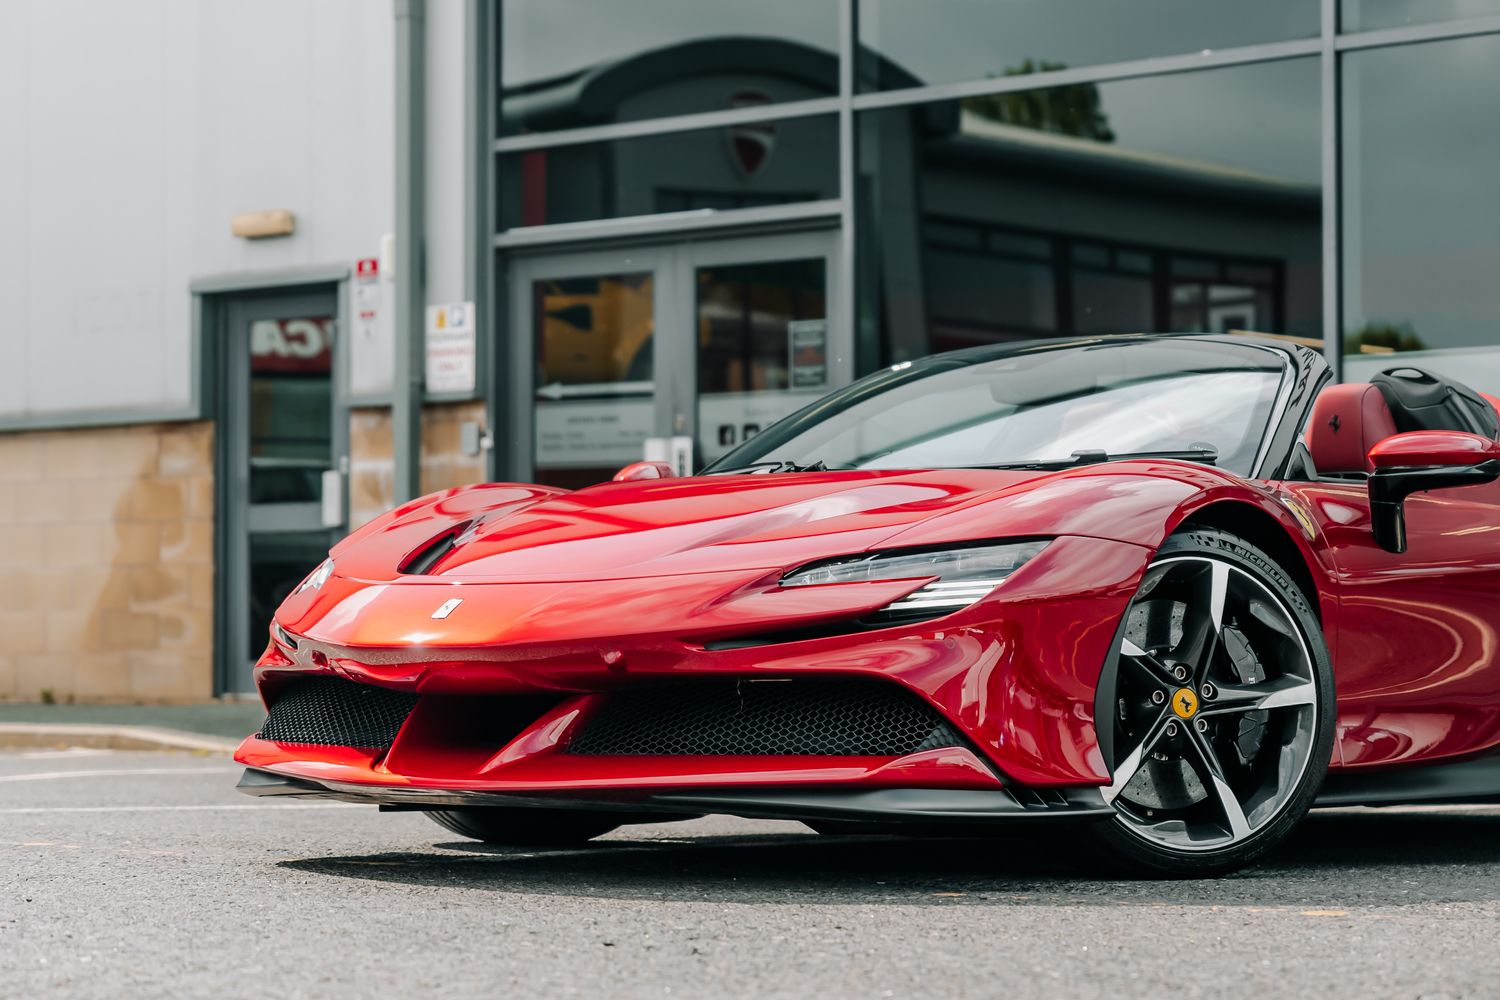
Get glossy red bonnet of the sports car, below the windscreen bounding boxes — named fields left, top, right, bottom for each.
left=333, top=469, right=1046, bottom=583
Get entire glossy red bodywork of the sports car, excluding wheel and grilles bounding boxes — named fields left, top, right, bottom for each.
left=237, top=460, right=1500, bottom=795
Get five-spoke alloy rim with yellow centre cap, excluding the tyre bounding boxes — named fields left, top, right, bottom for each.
left=1104, top=555, right=1319, bottom=852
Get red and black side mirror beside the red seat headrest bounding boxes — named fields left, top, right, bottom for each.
left=1370, top=430, right=1500, bottom=552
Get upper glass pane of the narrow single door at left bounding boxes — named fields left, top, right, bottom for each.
left=249, top=316, right=333, bottom=503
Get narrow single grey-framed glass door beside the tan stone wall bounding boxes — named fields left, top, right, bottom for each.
left=219, top=286, right=344, bottom=693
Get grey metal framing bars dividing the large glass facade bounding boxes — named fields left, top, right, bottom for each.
left=470, top=0, right=1500, bottom=395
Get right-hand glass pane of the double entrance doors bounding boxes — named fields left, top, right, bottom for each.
left=698, top=258, right=830, bottom=462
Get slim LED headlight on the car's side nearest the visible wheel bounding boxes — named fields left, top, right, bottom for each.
left=782, top=540, right=1047, bottom=618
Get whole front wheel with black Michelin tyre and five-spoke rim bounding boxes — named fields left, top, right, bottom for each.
left=1089, top=529, right=1335, bottom=879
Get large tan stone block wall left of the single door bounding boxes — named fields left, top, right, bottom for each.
left=0, top=423, right=215, bottom=702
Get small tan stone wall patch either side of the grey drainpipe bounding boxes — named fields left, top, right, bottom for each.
left=350, top=402, right=485, bottom=529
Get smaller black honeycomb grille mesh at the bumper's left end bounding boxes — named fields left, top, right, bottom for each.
left=260, top=678, right=417, bottom=750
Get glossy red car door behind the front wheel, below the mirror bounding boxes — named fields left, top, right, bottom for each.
left=1281, top=481, right=1500, bottom=765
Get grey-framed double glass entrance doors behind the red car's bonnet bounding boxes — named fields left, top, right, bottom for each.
left=510, top=232, right=854, bottom=489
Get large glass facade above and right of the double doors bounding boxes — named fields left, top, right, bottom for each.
left=498, top=0, right=1500, bottom=390
